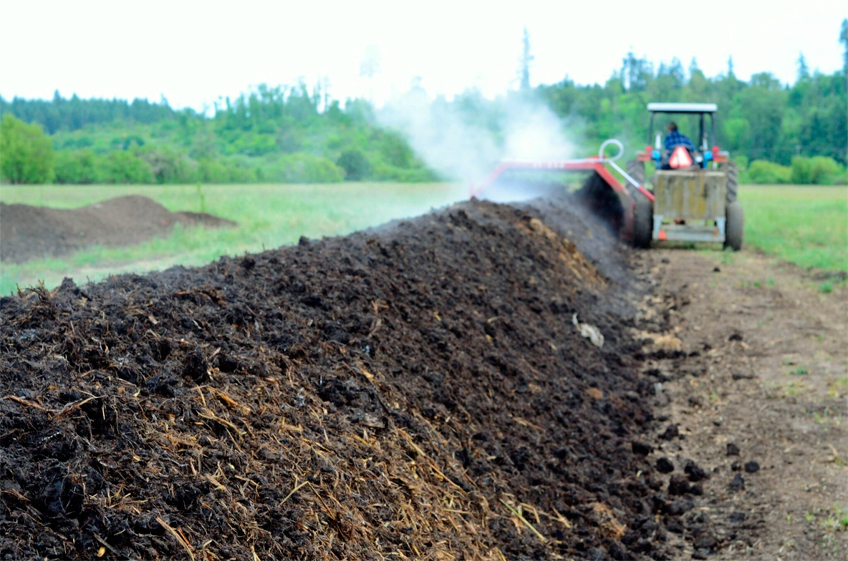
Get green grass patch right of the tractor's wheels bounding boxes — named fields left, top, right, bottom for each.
left=739, top=185, right=848, bottom=272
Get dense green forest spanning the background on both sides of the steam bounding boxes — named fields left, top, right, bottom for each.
left=0, top=33, right=848, bottom=184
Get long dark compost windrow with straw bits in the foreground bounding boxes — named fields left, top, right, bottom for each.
left=0, top=195, right=689, bottom=560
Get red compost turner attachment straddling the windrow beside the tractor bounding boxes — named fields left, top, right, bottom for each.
left=469, top=139, right=654, bottom=247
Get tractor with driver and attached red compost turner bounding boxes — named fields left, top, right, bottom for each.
left=471, top=103, right=745, bottom=251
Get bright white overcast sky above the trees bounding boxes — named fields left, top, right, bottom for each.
left=0, top=0, right=848, bottom=110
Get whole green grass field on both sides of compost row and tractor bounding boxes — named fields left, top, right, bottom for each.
left=0, top=183, right=848, bottom=295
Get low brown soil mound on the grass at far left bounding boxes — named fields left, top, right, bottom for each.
left=0, top=195, right=236, bottom=263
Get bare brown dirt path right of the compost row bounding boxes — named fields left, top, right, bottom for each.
left=644, top=250, right=848, bottom=560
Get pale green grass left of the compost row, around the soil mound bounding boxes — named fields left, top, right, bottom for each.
left=0, top=183, right=467, bottom=295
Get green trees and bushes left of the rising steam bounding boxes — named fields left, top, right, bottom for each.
left=0, top=84, right=436, bottom=184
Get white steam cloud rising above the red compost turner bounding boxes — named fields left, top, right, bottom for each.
left=377, top=88, right=576, bottom=200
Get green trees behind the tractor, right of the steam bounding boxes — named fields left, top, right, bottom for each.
left=540, top=53, right=848, bottom=165
